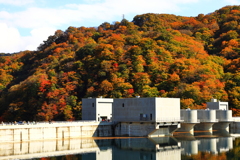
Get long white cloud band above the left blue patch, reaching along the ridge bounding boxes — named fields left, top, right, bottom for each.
left=0, top=0, right=202, bottom=29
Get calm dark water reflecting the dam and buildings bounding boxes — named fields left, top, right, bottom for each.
left=0, top=132, right=240, bottom=160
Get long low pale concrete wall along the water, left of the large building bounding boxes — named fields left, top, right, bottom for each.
left=0, top=122, right=113, bottom=142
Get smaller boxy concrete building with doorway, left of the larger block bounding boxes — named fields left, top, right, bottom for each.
left=82, top=98, right=113, bottom=122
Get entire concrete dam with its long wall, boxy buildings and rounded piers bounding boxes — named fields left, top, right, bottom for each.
left=0, top=97, right=239, bottom=142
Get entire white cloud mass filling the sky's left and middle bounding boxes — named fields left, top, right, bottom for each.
left=0, top=0, right=212, bottom=52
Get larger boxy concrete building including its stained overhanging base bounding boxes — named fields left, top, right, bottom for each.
left=113, top=97, right=181, bottom=137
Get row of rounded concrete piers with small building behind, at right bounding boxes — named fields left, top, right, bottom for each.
left=178, top=99, right=233, bottom=133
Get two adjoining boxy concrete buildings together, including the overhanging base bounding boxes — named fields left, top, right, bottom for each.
left=82, top=97, right=181, bottom=137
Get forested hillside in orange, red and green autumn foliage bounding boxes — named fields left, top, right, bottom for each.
left=0, top=6, right=240, bottom=121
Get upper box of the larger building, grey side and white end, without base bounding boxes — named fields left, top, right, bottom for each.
left=113, top=98, right=180, bottom=122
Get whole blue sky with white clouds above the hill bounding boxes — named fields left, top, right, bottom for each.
left=0, top=0, right=240, bottom=53
